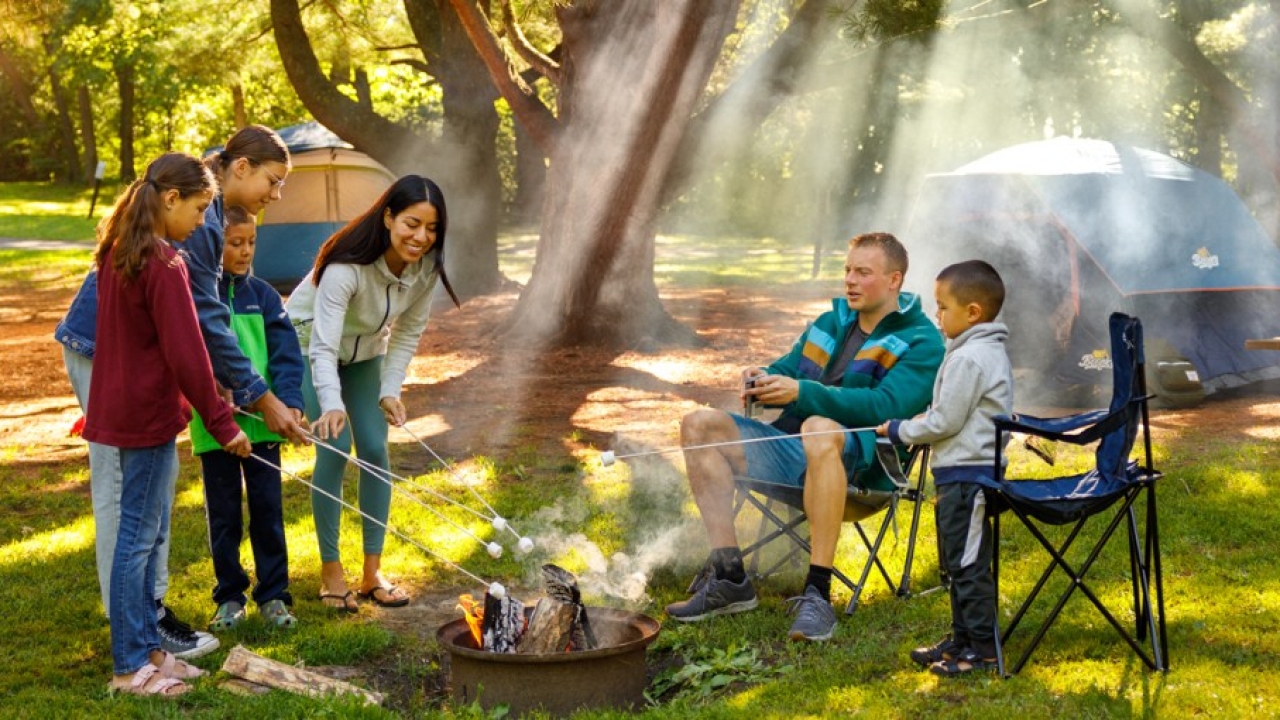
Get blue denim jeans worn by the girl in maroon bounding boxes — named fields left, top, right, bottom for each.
left=111, top=441, right=177, bottom=675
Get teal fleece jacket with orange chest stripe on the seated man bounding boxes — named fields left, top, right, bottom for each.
left=764, top=292, right=946, bottom=489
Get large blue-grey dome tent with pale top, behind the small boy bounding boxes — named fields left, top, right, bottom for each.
left=910, top=137, right=1280, bottom=405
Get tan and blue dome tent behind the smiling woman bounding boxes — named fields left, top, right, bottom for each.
left=253, top=122, right=396, bottom=293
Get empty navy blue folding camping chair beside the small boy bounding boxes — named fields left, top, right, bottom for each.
left=983, top=313, right=1169, bottom=676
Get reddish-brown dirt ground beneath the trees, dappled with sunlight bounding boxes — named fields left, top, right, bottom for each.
left=0, top=274, right=1280, bottom=705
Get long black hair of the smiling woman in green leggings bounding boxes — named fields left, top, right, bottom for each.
left=311, top=176, right=462, bottom=307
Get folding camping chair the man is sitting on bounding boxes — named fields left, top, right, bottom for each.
left=733, top=438, right=937, bottom=615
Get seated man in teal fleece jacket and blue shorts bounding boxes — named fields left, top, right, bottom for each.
left=667, top=233, right=943, bottom=641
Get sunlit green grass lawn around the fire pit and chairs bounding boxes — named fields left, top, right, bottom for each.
left=0, top=184, right=1280, bottom=719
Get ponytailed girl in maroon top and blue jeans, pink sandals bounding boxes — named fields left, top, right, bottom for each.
left=84, top=152, right=251, bottom=696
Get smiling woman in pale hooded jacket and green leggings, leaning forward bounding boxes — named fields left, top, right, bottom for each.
left=285, top=176, right=458, bottom=611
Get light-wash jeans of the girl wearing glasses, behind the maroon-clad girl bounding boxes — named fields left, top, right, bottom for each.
left=63, top=346, right=178, bottom=616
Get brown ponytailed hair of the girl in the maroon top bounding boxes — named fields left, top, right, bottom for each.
left=93, top=152, right=218, bottom=282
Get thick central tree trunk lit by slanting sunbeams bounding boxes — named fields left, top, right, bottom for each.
left=504, top=0, right=739, bottom=347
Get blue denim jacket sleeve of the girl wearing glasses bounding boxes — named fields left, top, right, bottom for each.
left=178, top=196, right=268, bottom=406
